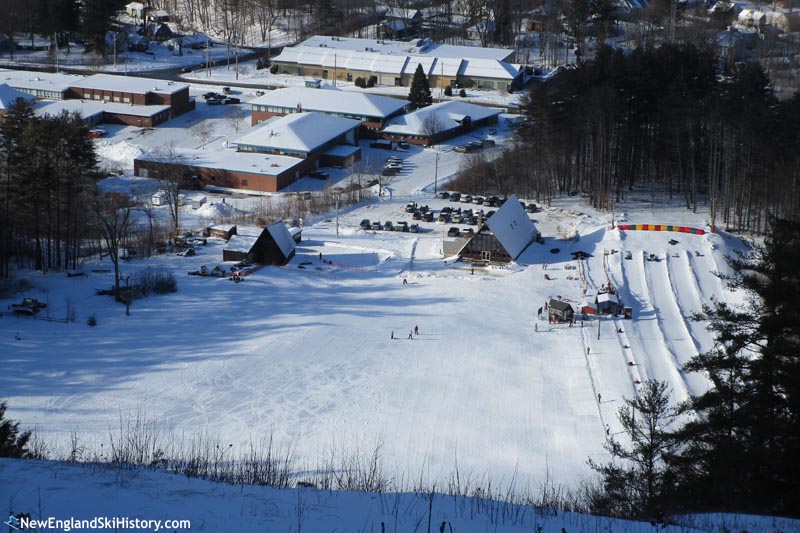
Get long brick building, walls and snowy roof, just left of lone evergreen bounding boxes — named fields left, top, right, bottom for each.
left=250, top=87, right=408, bottom=131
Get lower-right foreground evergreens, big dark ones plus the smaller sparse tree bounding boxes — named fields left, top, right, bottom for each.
left=589, top=219, right=800, bottom=520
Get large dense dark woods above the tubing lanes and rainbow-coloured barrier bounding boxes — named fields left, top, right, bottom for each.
left=454, top=45, right=800, bottom=233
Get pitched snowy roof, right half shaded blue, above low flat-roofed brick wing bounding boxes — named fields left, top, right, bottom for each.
left=235, top=111, right=361, bottom=152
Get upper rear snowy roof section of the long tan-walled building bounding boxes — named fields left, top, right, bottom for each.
left=296, top=35, right=514, bottom=60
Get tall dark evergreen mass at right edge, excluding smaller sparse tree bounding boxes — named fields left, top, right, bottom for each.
left=673, top=220, right=800, bottom=516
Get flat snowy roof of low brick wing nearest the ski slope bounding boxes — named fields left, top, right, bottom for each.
left=136, top=148, right=304, bottom=176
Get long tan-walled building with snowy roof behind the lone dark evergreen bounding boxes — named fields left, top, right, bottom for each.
left=272, top=35, right=522, bottom=90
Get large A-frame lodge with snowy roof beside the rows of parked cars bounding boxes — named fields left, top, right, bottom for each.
left=458, top=195, right=539, bottom=263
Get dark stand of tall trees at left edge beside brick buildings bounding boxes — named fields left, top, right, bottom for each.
left=0, top=100, right=96, bottom=278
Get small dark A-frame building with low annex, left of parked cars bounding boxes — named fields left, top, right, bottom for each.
left=222, top=221, right=295, bottom=265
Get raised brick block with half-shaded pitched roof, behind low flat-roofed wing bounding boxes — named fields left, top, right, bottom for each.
left=234, top=112, right=361, bottom=170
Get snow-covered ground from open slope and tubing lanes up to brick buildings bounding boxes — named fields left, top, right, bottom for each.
left=0, top=69, right=760, bottom=528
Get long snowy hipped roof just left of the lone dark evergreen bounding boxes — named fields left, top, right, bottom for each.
left=250, top=87, right=408, bottom=118
